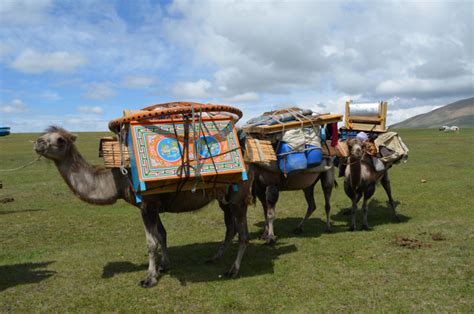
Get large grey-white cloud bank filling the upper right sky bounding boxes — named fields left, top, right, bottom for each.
left=165, top=1, right=474, bottom=103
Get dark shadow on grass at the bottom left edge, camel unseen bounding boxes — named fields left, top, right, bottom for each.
left=0, top=262, right=56, bottom=292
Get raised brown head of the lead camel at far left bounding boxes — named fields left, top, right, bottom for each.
left=34, top=126, right=76, bottom=161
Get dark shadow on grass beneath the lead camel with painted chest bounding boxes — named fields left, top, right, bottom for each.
left=102, top=241, right=297, bottom=286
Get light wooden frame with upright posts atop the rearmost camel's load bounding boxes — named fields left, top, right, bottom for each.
left=344, top=101, right=388, bottom=132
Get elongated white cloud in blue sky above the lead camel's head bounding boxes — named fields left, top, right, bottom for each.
left=10, top=49, right=86, bottom=74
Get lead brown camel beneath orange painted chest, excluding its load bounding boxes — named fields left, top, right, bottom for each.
left=34, top=126, right=251, bottom=288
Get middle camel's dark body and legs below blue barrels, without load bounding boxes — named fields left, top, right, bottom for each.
left=252, top=158, right=336, bottom=244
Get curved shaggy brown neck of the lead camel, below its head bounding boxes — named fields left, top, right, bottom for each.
left=56, top=146, right=121, bottom=204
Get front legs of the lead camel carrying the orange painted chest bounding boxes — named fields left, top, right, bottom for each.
left=139, top=203, right=169, bottom=288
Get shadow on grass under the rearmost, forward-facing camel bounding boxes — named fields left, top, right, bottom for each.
left=331, top=199, right=411, bottom=227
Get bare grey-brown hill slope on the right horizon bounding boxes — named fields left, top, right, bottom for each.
left=390, top=97, right=474, bottom=129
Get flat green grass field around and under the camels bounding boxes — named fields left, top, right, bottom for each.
left=0, top=129, right=474, bottom=312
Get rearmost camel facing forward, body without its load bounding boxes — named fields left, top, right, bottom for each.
left=344, top=138, right=399, bottom=231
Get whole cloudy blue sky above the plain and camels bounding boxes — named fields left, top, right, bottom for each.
left=0, top=0, right=474, bottom=132
